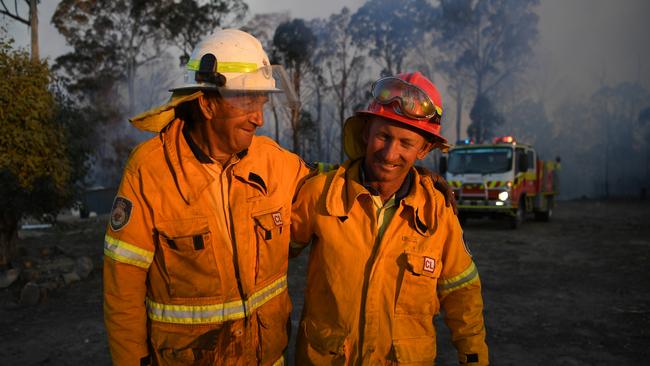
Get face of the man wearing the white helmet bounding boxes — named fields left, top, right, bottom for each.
left=212, top=94, right=268, bottom=154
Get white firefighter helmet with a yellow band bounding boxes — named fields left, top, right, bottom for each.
left=171, top=29, right=281, bottom=92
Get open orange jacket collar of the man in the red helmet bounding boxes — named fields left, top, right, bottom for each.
left=325, top=158, right=439, bottom=236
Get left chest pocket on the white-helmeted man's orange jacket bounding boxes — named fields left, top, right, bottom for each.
left=157, top=218, right=221, bottom=298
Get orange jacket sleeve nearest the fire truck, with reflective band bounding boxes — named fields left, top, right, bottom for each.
left=438, top=208, right=489, bottom=366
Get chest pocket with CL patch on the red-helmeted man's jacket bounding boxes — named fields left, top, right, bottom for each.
left=395, top=252, right=442, bottom=315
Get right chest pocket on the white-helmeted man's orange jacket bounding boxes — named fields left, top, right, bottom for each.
left=252, top=206, right=290, bottom=283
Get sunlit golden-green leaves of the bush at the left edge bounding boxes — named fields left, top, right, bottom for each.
left=0, top=35, right=71, bottom=194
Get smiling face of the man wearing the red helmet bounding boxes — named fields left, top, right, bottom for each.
left=364, top=116, right=430, bottom=182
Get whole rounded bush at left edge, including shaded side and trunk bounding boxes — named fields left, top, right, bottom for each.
left=0, top=30, right=92, bottom=269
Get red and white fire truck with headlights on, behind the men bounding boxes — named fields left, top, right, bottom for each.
left=440, top=136, right=559, bottom=228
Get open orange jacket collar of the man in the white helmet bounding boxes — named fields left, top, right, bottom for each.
left=160, top=119, right=269, bottom=204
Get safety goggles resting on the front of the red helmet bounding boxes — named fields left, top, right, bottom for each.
left=371, top=76, right=442, bottom=124
